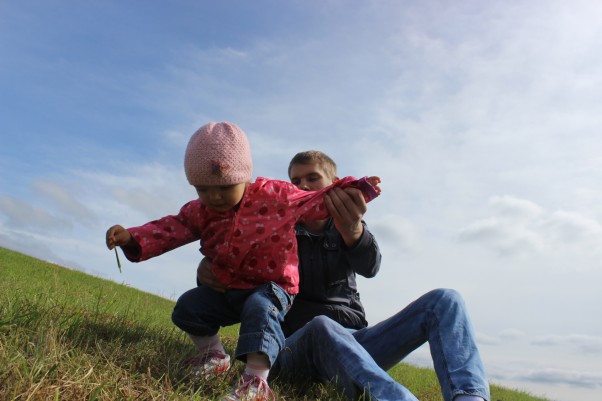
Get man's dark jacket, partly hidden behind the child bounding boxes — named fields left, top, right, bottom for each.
left=282, top=219, right=381, bottom=337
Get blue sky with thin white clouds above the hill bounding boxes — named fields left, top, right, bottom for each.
left=0, top=0, right=602, bottom=401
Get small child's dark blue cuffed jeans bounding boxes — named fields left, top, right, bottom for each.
left=171, top=283, right=293, bottom=366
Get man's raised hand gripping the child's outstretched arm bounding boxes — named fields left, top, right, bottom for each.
left=324, top=187, right=368, bottom=248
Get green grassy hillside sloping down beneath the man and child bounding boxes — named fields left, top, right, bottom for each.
left=0, top=248, right=545, bottom=401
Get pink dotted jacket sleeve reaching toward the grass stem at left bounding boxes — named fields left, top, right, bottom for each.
left=123, top=200, right=201, bottom=262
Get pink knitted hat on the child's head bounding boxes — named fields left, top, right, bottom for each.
left=184, top=122, right=253, bottom=185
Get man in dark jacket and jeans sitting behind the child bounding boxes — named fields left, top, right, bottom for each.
left=199, top=151, right=490, bottom=401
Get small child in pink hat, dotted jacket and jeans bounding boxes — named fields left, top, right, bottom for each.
left=106, top=122, right=380, bottom=400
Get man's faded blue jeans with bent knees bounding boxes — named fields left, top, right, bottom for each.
left=272, top=289, right=490, bottom=401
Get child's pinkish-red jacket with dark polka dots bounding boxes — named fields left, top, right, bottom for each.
left=124, top=177, right=378, bottom=294
